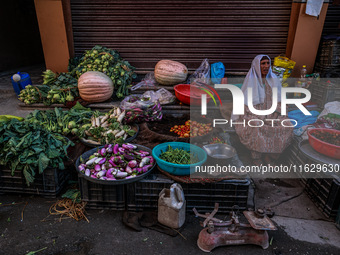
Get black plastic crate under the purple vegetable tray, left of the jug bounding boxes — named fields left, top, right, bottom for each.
left=78, top=175, right=125, bottom=211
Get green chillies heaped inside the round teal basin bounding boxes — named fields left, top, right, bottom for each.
left=159, top=145, right=199, bottom=165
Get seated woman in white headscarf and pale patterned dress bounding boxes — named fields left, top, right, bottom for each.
left=232, top=55, right=293, bottom=165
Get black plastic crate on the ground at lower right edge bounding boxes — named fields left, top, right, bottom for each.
left=305, top=177, right=340, bottom=219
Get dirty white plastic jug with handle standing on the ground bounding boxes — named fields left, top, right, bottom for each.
left=158, top=183, right=186, bottom=228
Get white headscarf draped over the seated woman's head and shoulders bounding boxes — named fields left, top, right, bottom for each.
left=241, top=55, right=281, bottom=106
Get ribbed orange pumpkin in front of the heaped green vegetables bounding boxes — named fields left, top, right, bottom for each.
left=78, top=71, right=114, bottom=102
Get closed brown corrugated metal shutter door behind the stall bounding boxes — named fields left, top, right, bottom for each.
left=71, top=0, right=292, bottom=73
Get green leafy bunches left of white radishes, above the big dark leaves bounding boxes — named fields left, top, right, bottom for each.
left=25, top=103, right=92, bottom=135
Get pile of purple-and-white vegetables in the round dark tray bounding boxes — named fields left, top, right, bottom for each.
left=78, top=143, right=154, bottom=181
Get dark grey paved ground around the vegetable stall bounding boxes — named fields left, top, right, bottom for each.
left=0, top=68, right=340, bottom=255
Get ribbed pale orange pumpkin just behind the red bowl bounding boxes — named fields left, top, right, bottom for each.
left=155, top=60, right=188, bottom=85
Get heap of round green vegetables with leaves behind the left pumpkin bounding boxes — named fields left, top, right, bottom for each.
left=19, top=45, right=137, bottom=105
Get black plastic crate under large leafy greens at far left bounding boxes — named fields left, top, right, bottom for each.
left=0, top=166, right=70, bottom=198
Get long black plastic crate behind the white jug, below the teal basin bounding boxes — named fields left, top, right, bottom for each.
left=126, top=174, right=250, bottom=213
